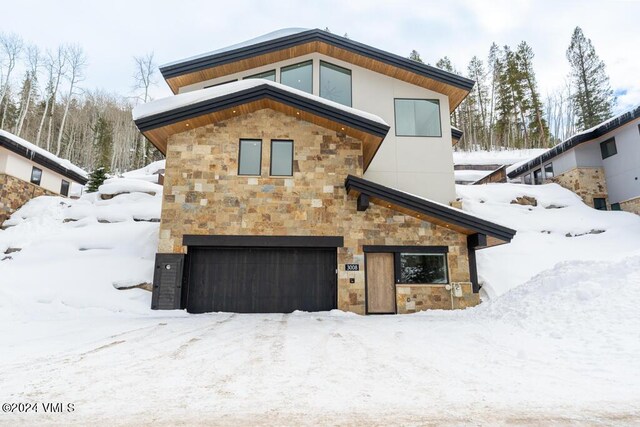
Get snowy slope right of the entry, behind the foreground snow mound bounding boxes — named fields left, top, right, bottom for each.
left=456, top=184, right=640, bottom=297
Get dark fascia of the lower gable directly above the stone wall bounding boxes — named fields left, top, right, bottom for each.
left=135, top=84, right=389, bottom=138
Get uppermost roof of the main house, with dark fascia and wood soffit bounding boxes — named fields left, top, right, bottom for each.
left=160, top=28, right=475, bottom=111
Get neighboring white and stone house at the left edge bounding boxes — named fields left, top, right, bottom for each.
left=0, top=130, right=87, bottom=225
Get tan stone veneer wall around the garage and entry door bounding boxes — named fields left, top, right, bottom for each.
left=159, top=110, right=479, bottom=314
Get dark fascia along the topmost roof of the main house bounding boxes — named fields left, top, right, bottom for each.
left=160, top=29, right=475, bottom=91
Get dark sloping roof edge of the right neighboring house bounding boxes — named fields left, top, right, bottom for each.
left=507, top=106, right=640, bottom=178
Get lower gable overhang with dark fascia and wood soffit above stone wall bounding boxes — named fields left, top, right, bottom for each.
left=135, top=83, right=389, bottom=170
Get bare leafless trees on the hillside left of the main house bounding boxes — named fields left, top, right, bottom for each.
left=0, top=33, right=161, bottom=172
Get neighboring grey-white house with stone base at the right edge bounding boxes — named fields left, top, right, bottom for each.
left=508, top=107, right=640, bottom=214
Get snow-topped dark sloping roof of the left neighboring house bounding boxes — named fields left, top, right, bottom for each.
left=0, top=130, right=87, bottom=185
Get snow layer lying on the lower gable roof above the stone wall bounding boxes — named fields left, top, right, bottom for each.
left=133, top=79, right=388, bottom=126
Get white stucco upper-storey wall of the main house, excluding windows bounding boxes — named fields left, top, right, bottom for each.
left=180, top=53, right=456, bottom=204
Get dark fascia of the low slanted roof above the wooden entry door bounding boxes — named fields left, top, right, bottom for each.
left=345, top=175, right=516, bottom=242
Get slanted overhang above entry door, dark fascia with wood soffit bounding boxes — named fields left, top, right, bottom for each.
left=345, top=175, right=516, bottom=249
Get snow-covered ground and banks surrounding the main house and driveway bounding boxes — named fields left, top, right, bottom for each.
left=0, top=170, right=640, bottom=425
